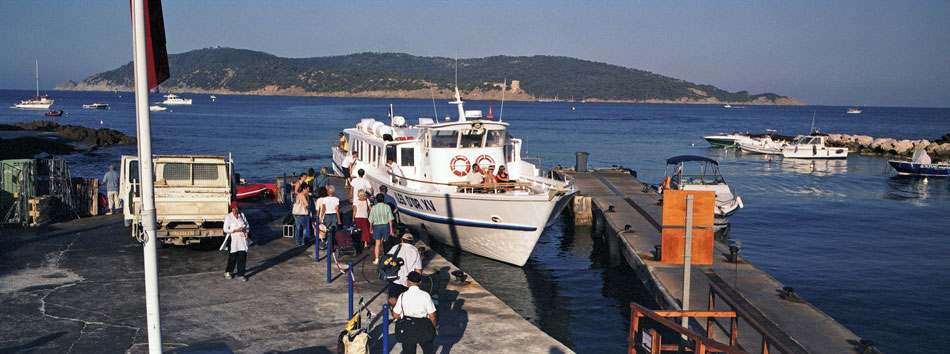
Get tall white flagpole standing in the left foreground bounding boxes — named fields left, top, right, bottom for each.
left=132, top=0, right=162, bottom=354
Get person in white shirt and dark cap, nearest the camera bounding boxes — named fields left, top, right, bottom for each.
left=392, top=271, right=439, bottom=354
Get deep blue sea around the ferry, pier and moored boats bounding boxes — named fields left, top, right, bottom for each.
left=0, top=90, right=950, bottom=353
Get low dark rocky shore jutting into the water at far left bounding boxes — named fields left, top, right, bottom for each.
left=0, top=120, right=135, bottom=160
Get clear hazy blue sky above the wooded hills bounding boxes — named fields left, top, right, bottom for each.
left=0, top=0, right=950, bottom=107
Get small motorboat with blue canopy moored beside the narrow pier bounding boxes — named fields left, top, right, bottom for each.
left=663, top=155, right=743, bottom=230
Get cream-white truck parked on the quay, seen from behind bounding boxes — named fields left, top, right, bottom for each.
left=119, top=155, right=235, bottom=245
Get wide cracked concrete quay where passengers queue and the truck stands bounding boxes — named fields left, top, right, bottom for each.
left=0, top=181, right=571, bottom=353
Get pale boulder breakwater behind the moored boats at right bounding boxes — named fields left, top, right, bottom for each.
left=828, top=134, right=950, bottom=160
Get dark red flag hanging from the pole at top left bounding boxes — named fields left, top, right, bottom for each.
left=129, top=0, right=171, bottom=90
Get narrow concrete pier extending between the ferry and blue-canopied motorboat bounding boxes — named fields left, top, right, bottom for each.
left=566, top=169, right=863, bottom=353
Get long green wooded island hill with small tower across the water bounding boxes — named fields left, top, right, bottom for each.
left=63, top=47, right=800, bottom=104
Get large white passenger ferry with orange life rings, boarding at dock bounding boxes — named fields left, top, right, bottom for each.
left=332, top=88, right=577, bottom=266
